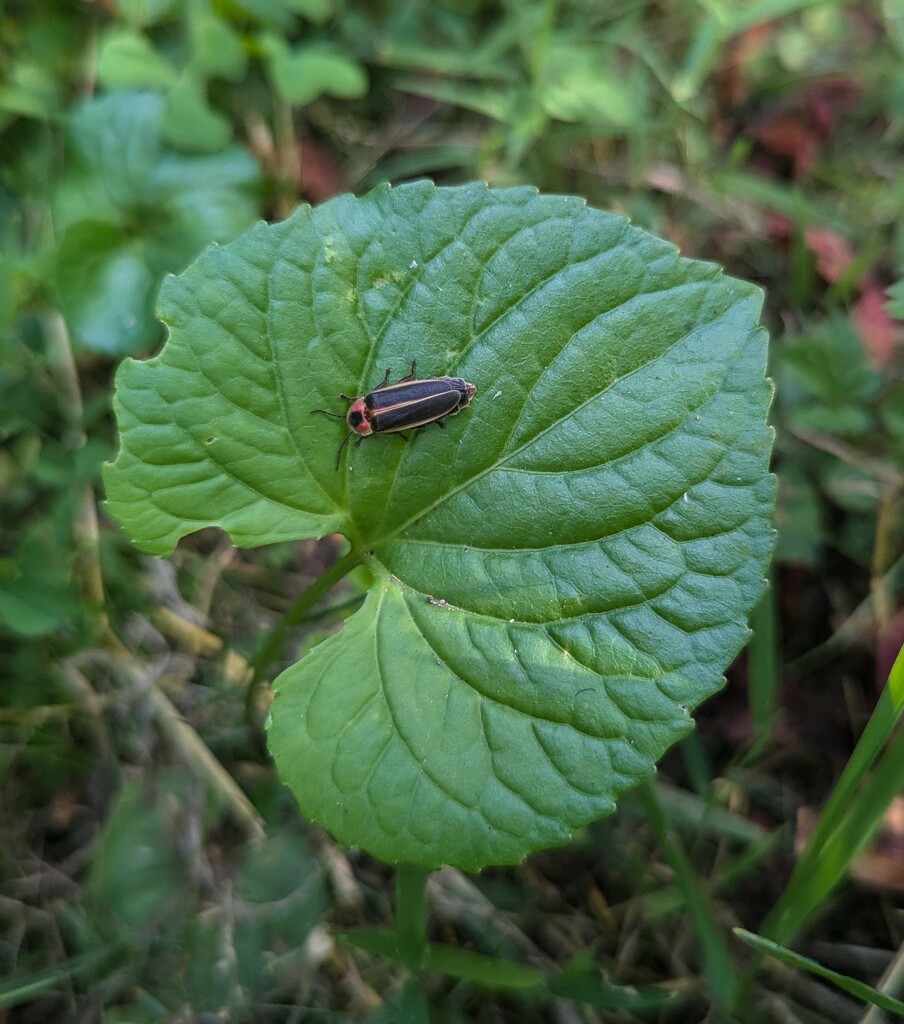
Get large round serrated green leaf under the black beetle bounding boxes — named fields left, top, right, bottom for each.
left=105, top=182, right=774, bottom=869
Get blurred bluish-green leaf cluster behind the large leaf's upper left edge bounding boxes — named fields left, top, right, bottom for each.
left=54, top=93, right=259, bottom=354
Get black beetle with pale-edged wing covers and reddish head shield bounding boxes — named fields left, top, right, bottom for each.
left=311, top=359, right=477, bottom=469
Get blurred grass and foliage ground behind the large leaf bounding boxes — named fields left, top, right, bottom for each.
left=0, top=0, right=904, bottom=1021
